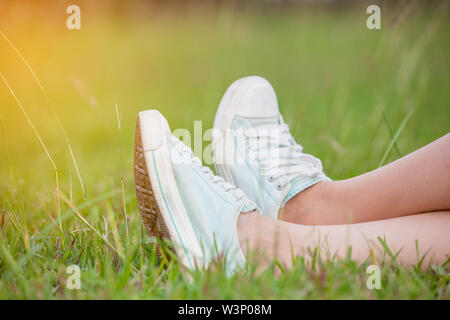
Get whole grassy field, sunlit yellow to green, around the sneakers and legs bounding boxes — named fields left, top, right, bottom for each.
left=0, top=2, right=450, bottom=299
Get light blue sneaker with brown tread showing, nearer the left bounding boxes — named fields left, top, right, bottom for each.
left=134, top=110, right=256, bottom=274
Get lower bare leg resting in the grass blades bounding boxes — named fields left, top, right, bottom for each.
left=238, top=212, right=450, bottom=267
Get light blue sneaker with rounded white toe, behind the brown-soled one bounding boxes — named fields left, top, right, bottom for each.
left=212, top=76, right=330, bottom=219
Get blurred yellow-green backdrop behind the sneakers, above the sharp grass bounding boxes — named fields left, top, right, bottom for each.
left=0, top=1, right=450, bottom=300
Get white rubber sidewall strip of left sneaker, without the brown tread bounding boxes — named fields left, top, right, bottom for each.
left=139, top=110, right=204, bottom=269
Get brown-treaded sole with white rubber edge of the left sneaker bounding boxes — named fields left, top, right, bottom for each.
left=134, top=110, right=202, bottom=270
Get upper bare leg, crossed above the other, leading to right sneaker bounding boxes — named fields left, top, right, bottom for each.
left=280, top=134, right=450, bottom=225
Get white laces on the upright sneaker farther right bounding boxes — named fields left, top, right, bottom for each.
left=244, top=121, right=323, bottom=190
